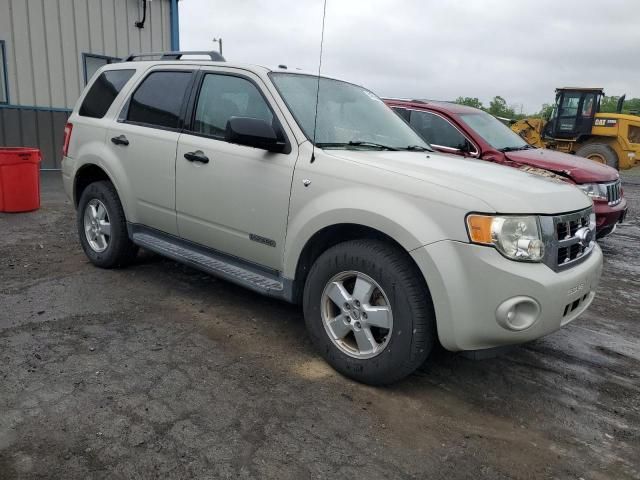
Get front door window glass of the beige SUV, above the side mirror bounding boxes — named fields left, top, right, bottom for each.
left=193, top=73, right=275, bottom=138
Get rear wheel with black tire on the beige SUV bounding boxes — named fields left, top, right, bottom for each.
left=77, top=181, right=138, bottom=268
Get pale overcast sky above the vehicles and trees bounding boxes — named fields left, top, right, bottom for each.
left=179, top=0, right=640, bottom=113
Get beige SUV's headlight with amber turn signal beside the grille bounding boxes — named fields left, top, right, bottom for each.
left=467, top=215, right=544, bottom=262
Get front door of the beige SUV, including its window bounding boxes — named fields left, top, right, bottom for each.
left=176, top=69, right=297, bottom=270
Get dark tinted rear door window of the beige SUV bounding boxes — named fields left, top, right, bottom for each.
left=126, top=71, right=191, bottom=128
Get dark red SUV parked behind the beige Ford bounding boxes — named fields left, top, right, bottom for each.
left=384, top=99, right=627, bottom=238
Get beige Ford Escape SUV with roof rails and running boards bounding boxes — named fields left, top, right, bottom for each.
left=62, top=53, right=602, bottom=384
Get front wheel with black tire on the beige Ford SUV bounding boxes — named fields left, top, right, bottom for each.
left=303, top=240, right=436, bottom=385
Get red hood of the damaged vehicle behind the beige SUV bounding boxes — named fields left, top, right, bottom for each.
left=505, top=148, right=619, bottom=183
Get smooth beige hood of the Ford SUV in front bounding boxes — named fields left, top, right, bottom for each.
left=325, top=150, right=592, bottom=214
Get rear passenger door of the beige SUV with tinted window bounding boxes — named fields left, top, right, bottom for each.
left=106, top=65, right=197, bottom=235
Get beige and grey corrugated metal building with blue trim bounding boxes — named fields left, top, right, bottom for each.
left=0, top=0, right=179, bottom=169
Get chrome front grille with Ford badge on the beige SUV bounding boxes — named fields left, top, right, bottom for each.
left=541, top=208, right=596, bottom=271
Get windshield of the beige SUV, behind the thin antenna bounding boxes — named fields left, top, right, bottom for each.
left=271, top=73, right=430, bottom=150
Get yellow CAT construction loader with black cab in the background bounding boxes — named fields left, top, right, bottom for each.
left=511, top=88, right=640, bottom=169
